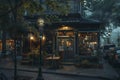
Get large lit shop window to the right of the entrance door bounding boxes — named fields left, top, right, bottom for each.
left=78, top=32, right=98, bottom=55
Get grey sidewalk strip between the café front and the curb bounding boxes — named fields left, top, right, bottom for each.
left=0, top=59, right=119, bottom=80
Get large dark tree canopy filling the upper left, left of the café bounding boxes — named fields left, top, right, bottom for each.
left=0, top=0, right=69, bottom=51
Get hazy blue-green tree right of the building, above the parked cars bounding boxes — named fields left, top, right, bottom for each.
left=84, top=0, right=120, bottom=39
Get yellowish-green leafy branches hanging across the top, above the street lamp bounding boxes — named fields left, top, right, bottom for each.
left=0, top=0, right=69, bottom=28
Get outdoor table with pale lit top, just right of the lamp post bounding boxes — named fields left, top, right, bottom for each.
left=45, top=56, right=60, bottom=69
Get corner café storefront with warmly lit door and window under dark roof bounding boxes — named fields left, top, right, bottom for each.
left=44, top=20, right=101, bottom=61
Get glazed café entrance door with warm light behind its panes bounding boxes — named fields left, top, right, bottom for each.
left=58, top=37, right=74, bottom=60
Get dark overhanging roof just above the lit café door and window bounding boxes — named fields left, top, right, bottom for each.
left=45, top=19, right=101, bottom=30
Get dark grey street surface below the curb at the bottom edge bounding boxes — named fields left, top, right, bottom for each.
left=0, top=70, right=107, bottom=80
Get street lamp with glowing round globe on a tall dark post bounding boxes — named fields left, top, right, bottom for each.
left=36, top=18, right=44, bottom=80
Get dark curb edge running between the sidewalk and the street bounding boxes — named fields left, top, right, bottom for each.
left=0, top=68, right=120, bottom=80
